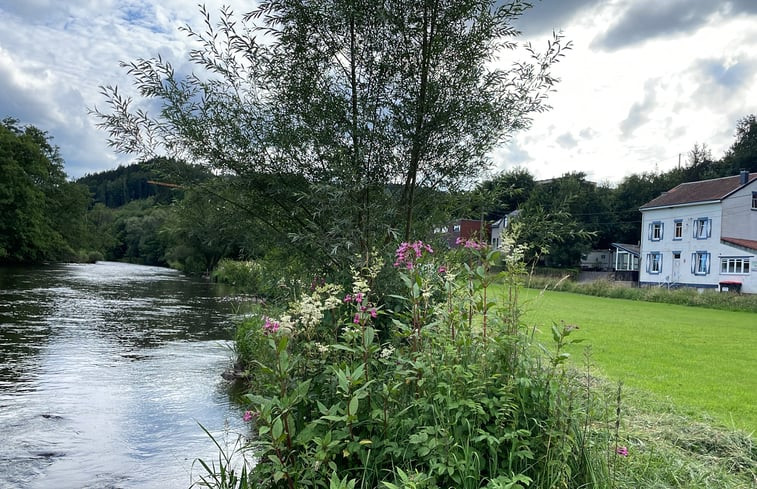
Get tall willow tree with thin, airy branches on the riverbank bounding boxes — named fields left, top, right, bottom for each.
left=94, top=0, right=567, bottom=268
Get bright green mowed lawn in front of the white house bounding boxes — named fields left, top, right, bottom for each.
left=521, top=289, right=757, bottom=434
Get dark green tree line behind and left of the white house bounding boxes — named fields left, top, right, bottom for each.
left=461, top=114, right=757, bottom=267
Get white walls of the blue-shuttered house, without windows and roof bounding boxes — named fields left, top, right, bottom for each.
left=639, top=200, right=757, bottom=293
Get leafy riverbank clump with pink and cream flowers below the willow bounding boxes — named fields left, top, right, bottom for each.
left=219, top=242, right=607, bottom=488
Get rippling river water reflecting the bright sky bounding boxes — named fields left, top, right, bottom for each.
left=0, top=262, right=250, bottom=489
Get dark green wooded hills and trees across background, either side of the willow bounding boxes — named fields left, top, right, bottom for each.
left=0, top=115, right=757, bottom=274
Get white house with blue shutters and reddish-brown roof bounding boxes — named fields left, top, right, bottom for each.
left=639, top=171, right=757, bottom=293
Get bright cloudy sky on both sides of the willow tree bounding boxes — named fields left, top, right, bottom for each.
left=0, top=0, right=757, bottom=185
